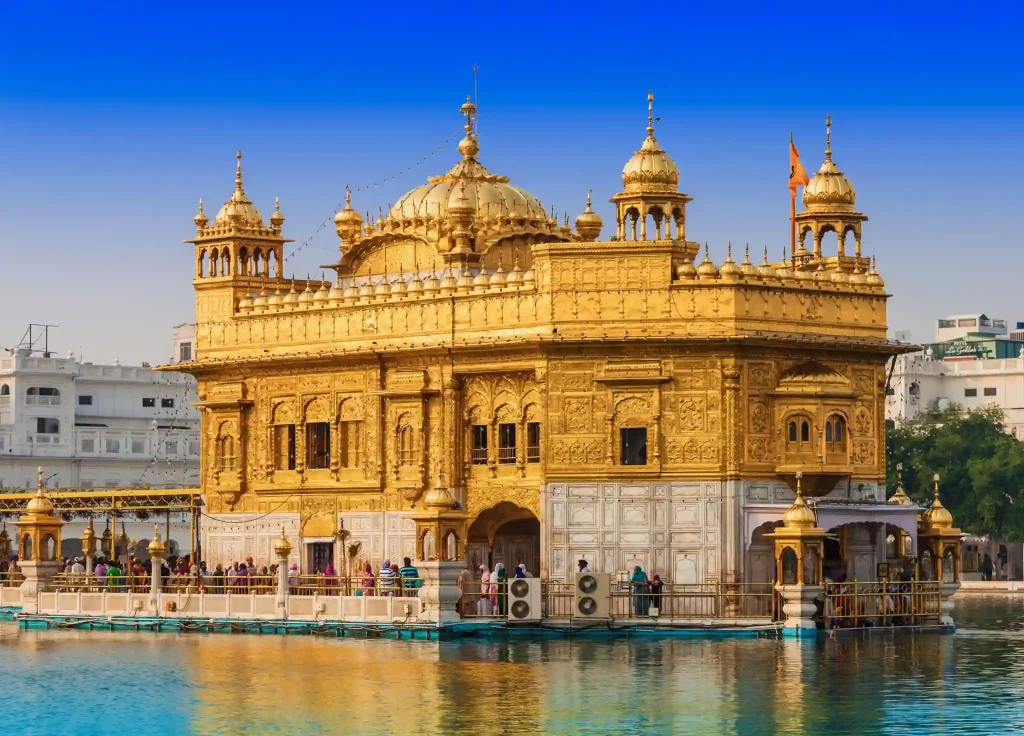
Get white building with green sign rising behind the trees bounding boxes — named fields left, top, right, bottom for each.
left=886, top=314, right=1024, bottom=439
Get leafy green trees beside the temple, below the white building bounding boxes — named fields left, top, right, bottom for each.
left=886, top=404, right=1024, bottom=540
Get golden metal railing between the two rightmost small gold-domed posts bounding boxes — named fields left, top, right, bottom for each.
left=824, top=580, right=942, bottom=629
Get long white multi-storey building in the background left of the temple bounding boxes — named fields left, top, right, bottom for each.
left=0, top=350, right=199, bottom=488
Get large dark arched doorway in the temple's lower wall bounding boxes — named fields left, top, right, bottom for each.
left=466, top=502, right=541, bottom=577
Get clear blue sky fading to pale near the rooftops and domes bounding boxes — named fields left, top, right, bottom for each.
left=0, top=0, right=1024, bottom=363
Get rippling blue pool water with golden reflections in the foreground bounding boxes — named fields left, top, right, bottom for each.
left=0, top=598, right=1024, bottom=736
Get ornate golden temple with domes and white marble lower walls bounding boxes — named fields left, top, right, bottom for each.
left=176, top=95, right=920, bottom=582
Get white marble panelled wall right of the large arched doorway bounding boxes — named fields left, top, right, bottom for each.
left=541, top=481, right=725, bottom=582
